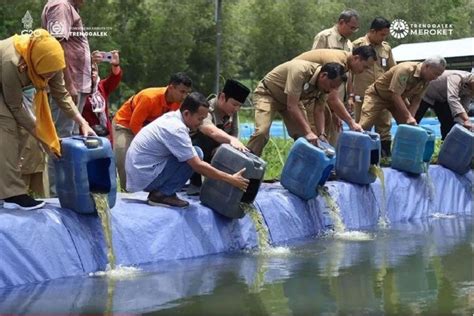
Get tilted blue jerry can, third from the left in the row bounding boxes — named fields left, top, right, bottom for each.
left=280, top=137, right=336, bottom=200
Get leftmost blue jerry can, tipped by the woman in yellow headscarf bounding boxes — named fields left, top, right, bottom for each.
left=54, top=136, right=117, bottom=214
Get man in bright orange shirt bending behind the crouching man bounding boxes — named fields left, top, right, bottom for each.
left=113, top=72, right=192, bottom=190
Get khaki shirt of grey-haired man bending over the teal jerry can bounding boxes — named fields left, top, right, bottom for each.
left=367, top=62, right=428, bottom=102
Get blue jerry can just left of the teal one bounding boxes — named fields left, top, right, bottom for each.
left=336, top=131, right=380, bottom=184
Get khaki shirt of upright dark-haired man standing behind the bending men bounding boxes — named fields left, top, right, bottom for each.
left=353, top=35, right=396, bottom=102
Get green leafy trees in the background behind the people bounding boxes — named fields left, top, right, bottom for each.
left=0, top=0, right=474, bottom=108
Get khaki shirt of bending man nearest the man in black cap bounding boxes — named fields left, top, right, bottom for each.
left=262, top=60, right=327, bottom=104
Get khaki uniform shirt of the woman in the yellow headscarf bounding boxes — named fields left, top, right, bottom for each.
left=0, top=37, right=79, bottom=131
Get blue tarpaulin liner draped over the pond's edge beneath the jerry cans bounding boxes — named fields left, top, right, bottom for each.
left=0, top=166, right=473, bottom=287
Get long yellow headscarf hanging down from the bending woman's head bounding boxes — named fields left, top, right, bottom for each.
left=13, top=29, right=66, bottom=156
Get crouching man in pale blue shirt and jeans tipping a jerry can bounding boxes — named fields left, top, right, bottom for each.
left=125, top=92, right=249, bottom=207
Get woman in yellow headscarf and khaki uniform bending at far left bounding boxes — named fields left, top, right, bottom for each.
left=0, top=29, right=94, bottom=210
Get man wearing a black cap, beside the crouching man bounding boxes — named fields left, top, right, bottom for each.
left=187, top=79, right=250, bottom=195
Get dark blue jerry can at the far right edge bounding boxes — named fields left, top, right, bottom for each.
left=438, top=124, right=474, bottom=174
